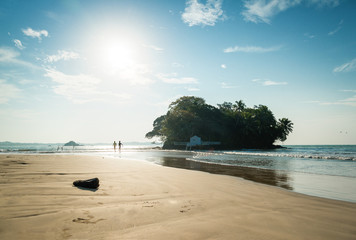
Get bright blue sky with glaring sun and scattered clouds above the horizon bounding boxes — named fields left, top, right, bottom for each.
left=0, top=0, right=356, bottom=145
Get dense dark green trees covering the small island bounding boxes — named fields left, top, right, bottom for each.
left=146, top=96, right=293, bottom=149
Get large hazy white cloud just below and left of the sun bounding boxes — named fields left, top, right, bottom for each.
left=45, top=69, right=130, bottom=103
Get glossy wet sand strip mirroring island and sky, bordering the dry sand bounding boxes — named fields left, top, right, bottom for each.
left=147, top=157, right=356, bottom=203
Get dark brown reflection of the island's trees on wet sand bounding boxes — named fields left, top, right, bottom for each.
left=157, top=157, right=293, bottom=190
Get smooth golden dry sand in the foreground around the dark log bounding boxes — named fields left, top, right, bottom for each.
left=0, top=155, right=356, bottom=240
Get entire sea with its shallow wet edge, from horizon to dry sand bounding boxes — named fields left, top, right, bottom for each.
left=0, top=142, right=356, bottom=202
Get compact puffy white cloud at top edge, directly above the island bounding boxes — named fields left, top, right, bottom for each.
left=182, top=0, right=224, bottom=27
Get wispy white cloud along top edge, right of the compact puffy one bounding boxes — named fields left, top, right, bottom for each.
left=242, top=0, right=340, bottom=23
